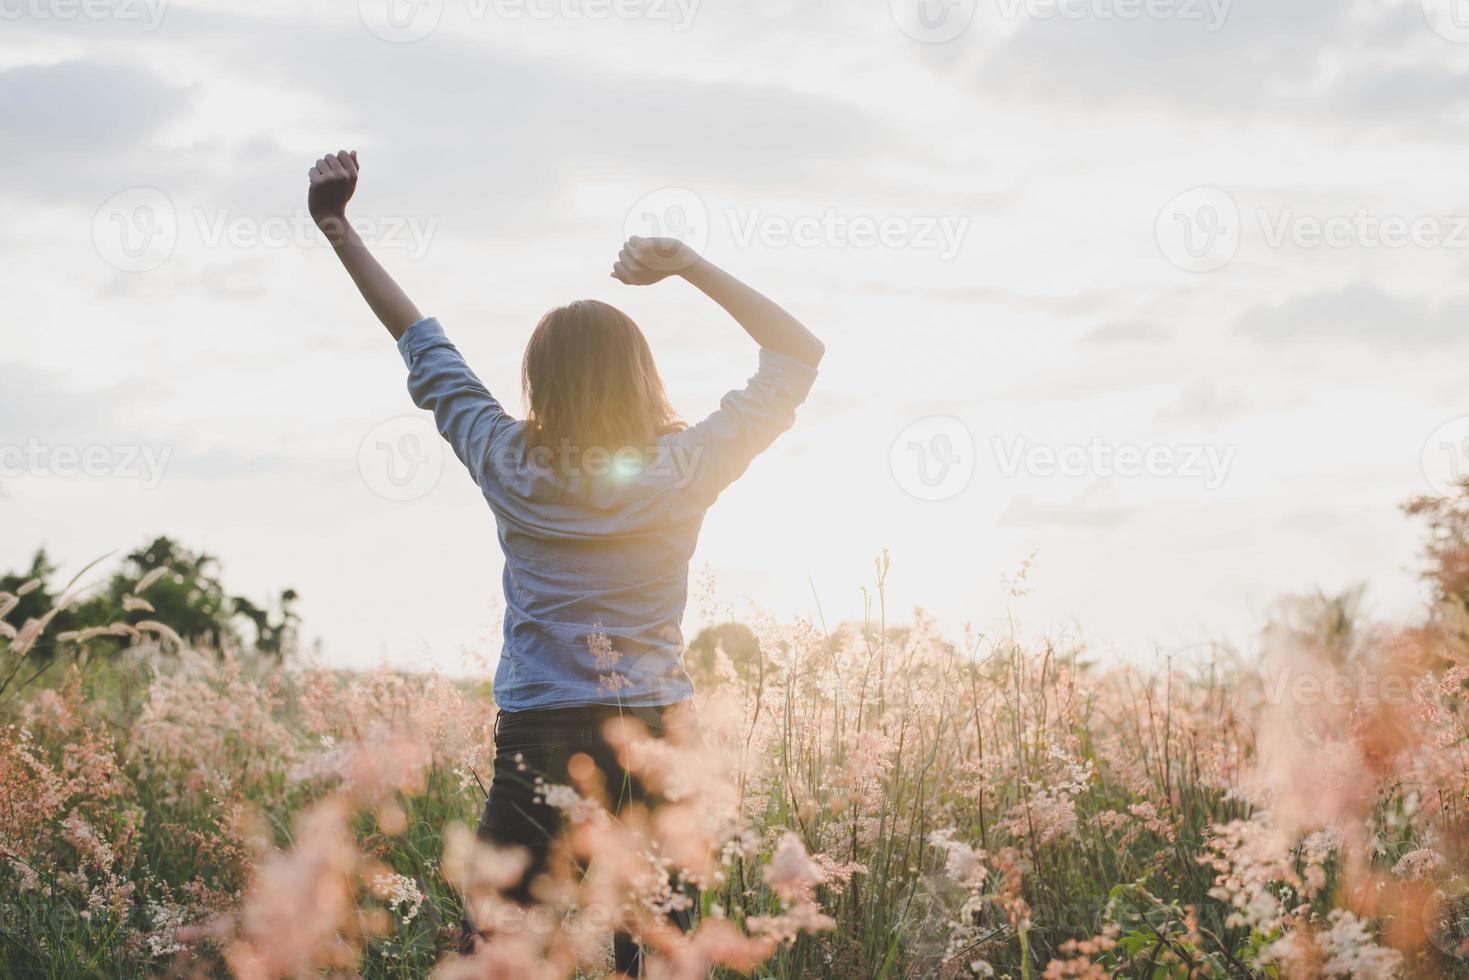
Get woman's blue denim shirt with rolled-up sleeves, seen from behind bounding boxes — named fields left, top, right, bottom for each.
left=398, top=317, right=817, bottom=711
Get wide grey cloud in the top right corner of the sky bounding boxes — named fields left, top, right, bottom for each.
left=972, top=0, right=1469, bottom=132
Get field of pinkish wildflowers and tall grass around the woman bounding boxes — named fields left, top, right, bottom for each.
left=0, top=491, right=1469, bottom=979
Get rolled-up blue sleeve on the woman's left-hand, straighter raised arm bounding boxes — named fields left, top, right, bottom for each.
left=398, top=317, right=514, bottom=482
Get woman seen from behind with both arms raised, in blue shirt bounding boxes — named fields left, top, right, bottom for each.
left=308, top=151, right=826, bottom=974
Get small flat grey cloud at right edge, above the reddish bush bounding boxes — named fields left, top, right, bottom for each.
left=1234, top=285, right=1469, bottom=350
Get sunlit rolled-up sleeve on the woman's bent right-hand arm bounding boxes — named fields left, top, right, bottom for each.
left=677, top=347, right=817, bottom=502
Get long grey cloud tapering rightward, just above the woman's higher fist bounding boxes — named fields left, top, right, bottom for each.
left=157, top=10, right=895, bottom=199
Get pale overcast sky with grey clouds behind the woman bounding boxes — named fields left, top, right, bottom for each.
left=0, top=0, right=1469, bottom=667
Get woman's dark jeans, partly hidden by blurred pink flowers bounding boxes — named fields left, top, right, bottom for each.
left=477, top=705, right=692, bottom=977
